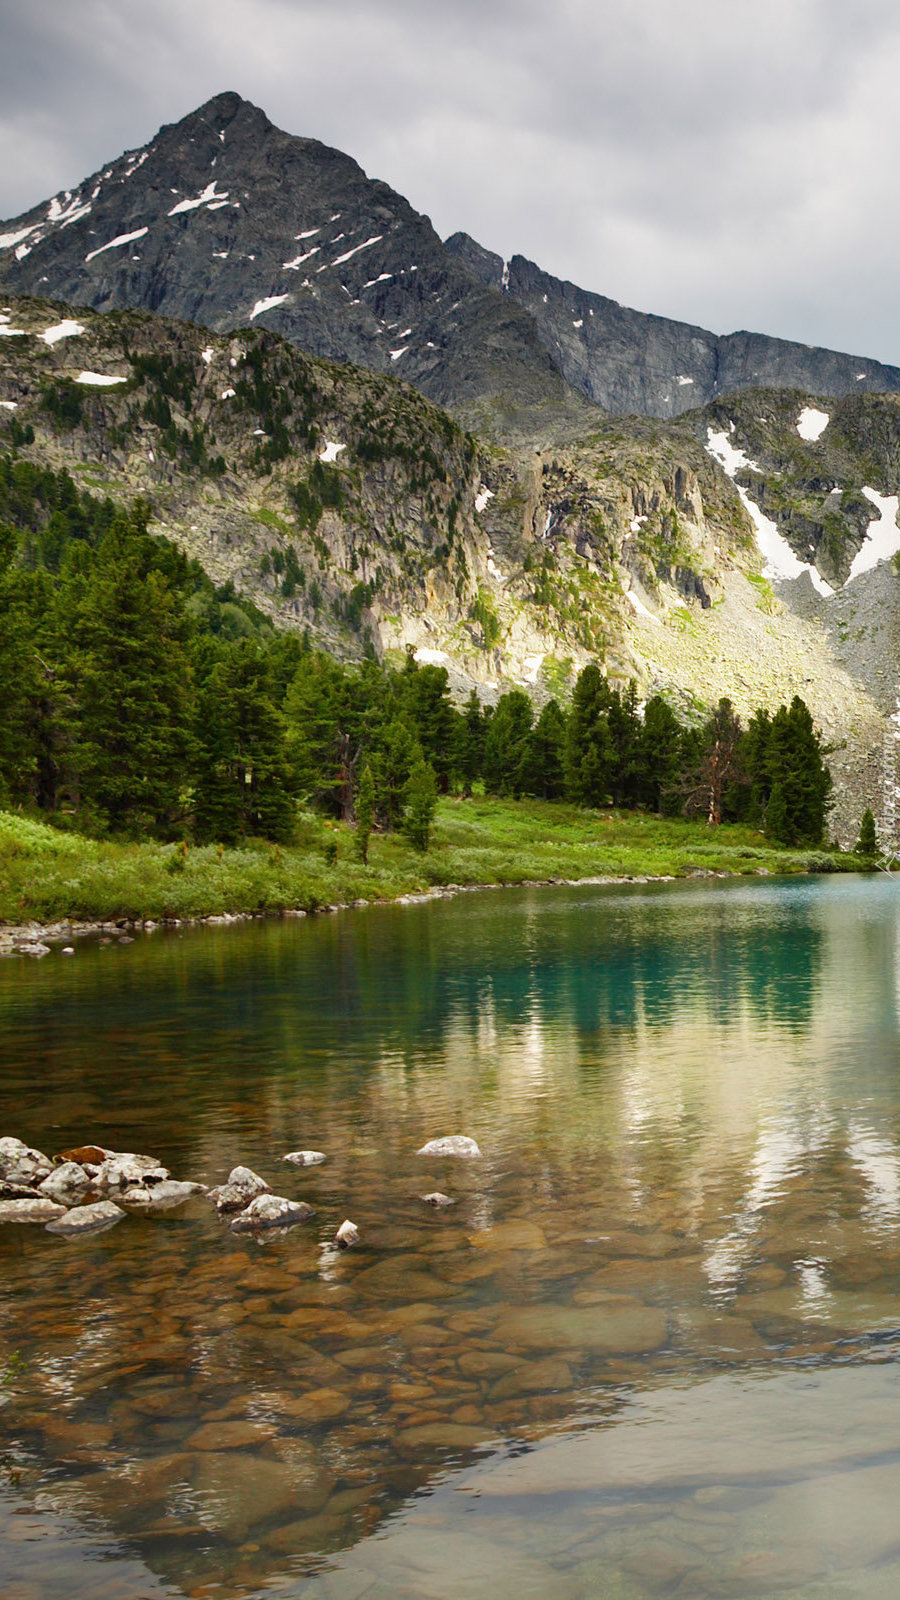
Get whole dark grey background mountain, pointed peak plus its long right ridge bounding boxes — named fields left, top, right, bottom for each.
left=0, top=94, right=900, bottom=442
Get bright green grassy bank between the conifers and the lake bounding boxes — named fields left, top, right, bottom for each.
left=0, top=798, right=865, bottom=926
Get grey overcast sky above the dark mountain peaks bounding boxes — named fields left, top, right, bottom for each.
left=0, top=0, right=900, bottom=363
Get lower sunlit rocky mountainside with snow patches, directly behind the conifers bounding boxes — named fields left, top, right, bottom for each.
left=0, top=298, right=900, bottom=838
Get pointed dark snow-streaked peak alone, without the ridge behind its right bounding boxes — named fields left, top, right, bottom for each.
left=0, top=94, right=582, bottom=432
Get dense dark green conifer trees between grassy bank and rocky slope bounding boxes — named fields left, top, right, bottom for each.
left=0, top=459, right=831, bottom=856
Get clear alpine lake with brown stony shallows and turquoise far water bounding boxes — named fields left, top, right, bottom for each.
left=0, top=875, right=900, bottom=1600
